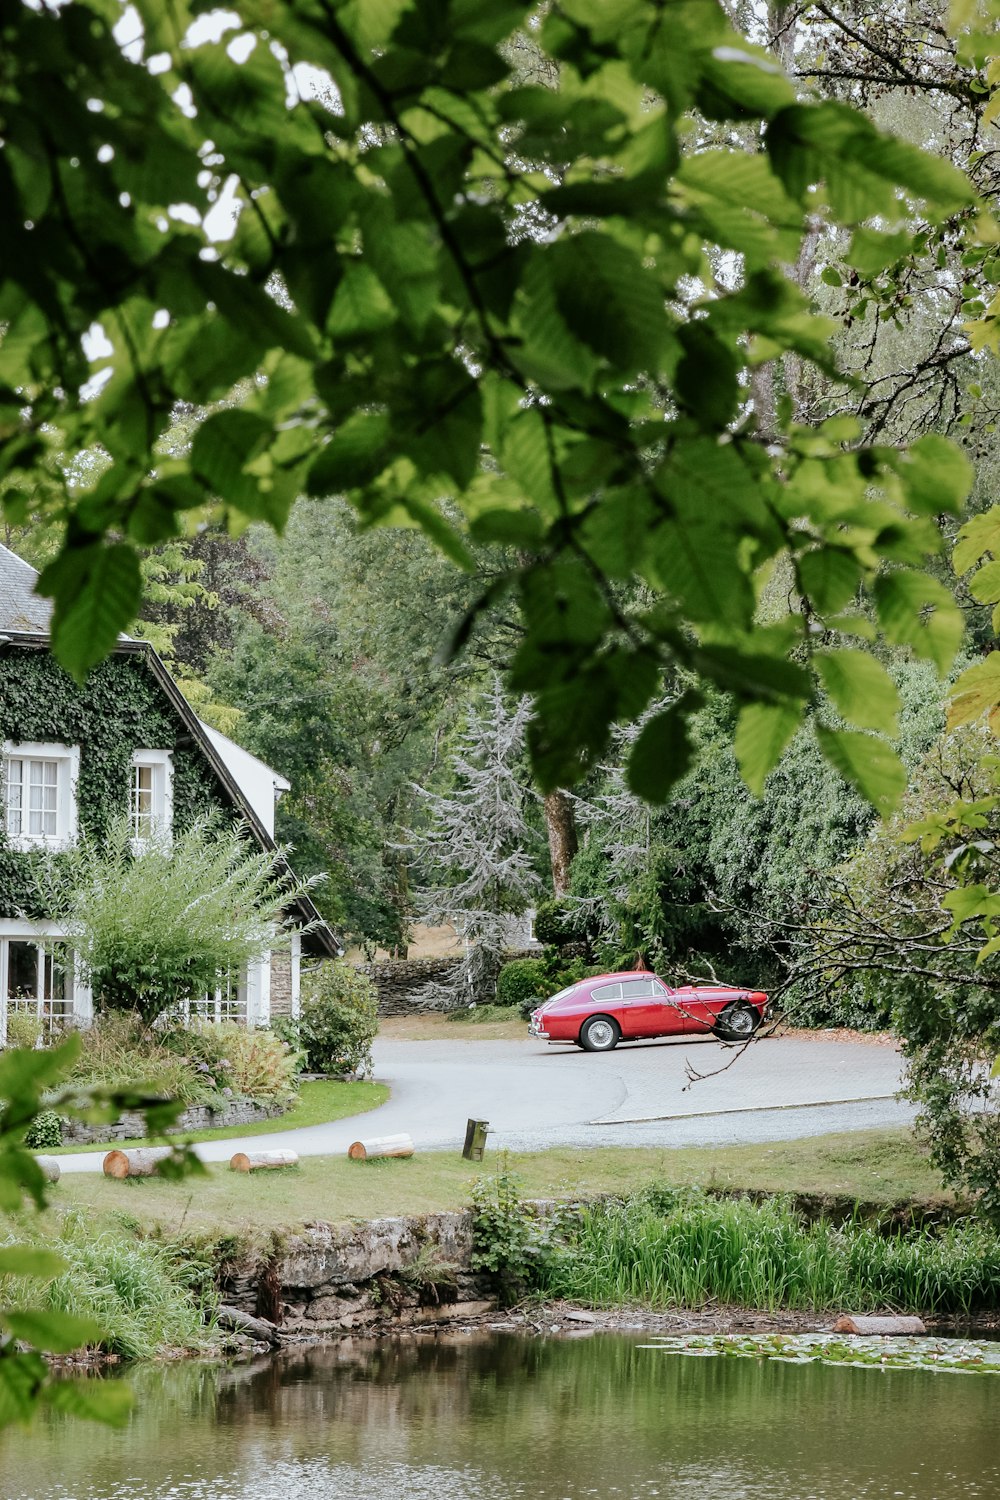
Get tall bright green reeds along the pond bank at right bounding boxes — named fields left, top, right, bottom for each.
left=540, top=1193, right=1000, bottom=1314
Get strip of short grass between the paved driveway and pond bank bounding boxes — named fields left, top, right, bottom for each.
left=52, top=1130, right=948, bottom=1241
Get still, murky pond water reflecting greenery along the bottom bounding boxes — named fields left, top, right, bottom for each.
left=0, top=1334, right=1000, bottom=1500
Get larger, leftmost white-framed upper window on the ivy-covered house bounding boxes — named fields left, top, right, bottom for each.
left=3, top=741, right=79, bottom=849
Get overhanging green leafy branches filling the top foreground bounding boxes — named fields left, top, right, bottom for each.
left=0, top=0, right=976, bottom=810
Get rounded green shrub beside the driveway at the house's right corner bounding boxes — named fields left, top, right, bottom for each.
left=298, top=960, right=378, bottom=1073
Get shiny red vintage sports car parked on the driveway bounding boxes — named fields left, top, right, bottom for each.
left=529, top=969, right=768, bottom=1052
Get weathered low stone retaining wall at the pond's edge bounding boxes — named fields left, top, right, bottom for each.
left=220, top=1211, right=496, bottom=1335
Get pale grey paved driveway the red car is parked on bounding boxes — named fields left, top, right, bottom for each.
left=60, top=1037, right=915, bottom=1172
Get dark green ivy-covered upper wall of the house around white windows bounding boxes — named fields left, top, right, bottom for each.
left=0, top=648, right=231, bottom=917
